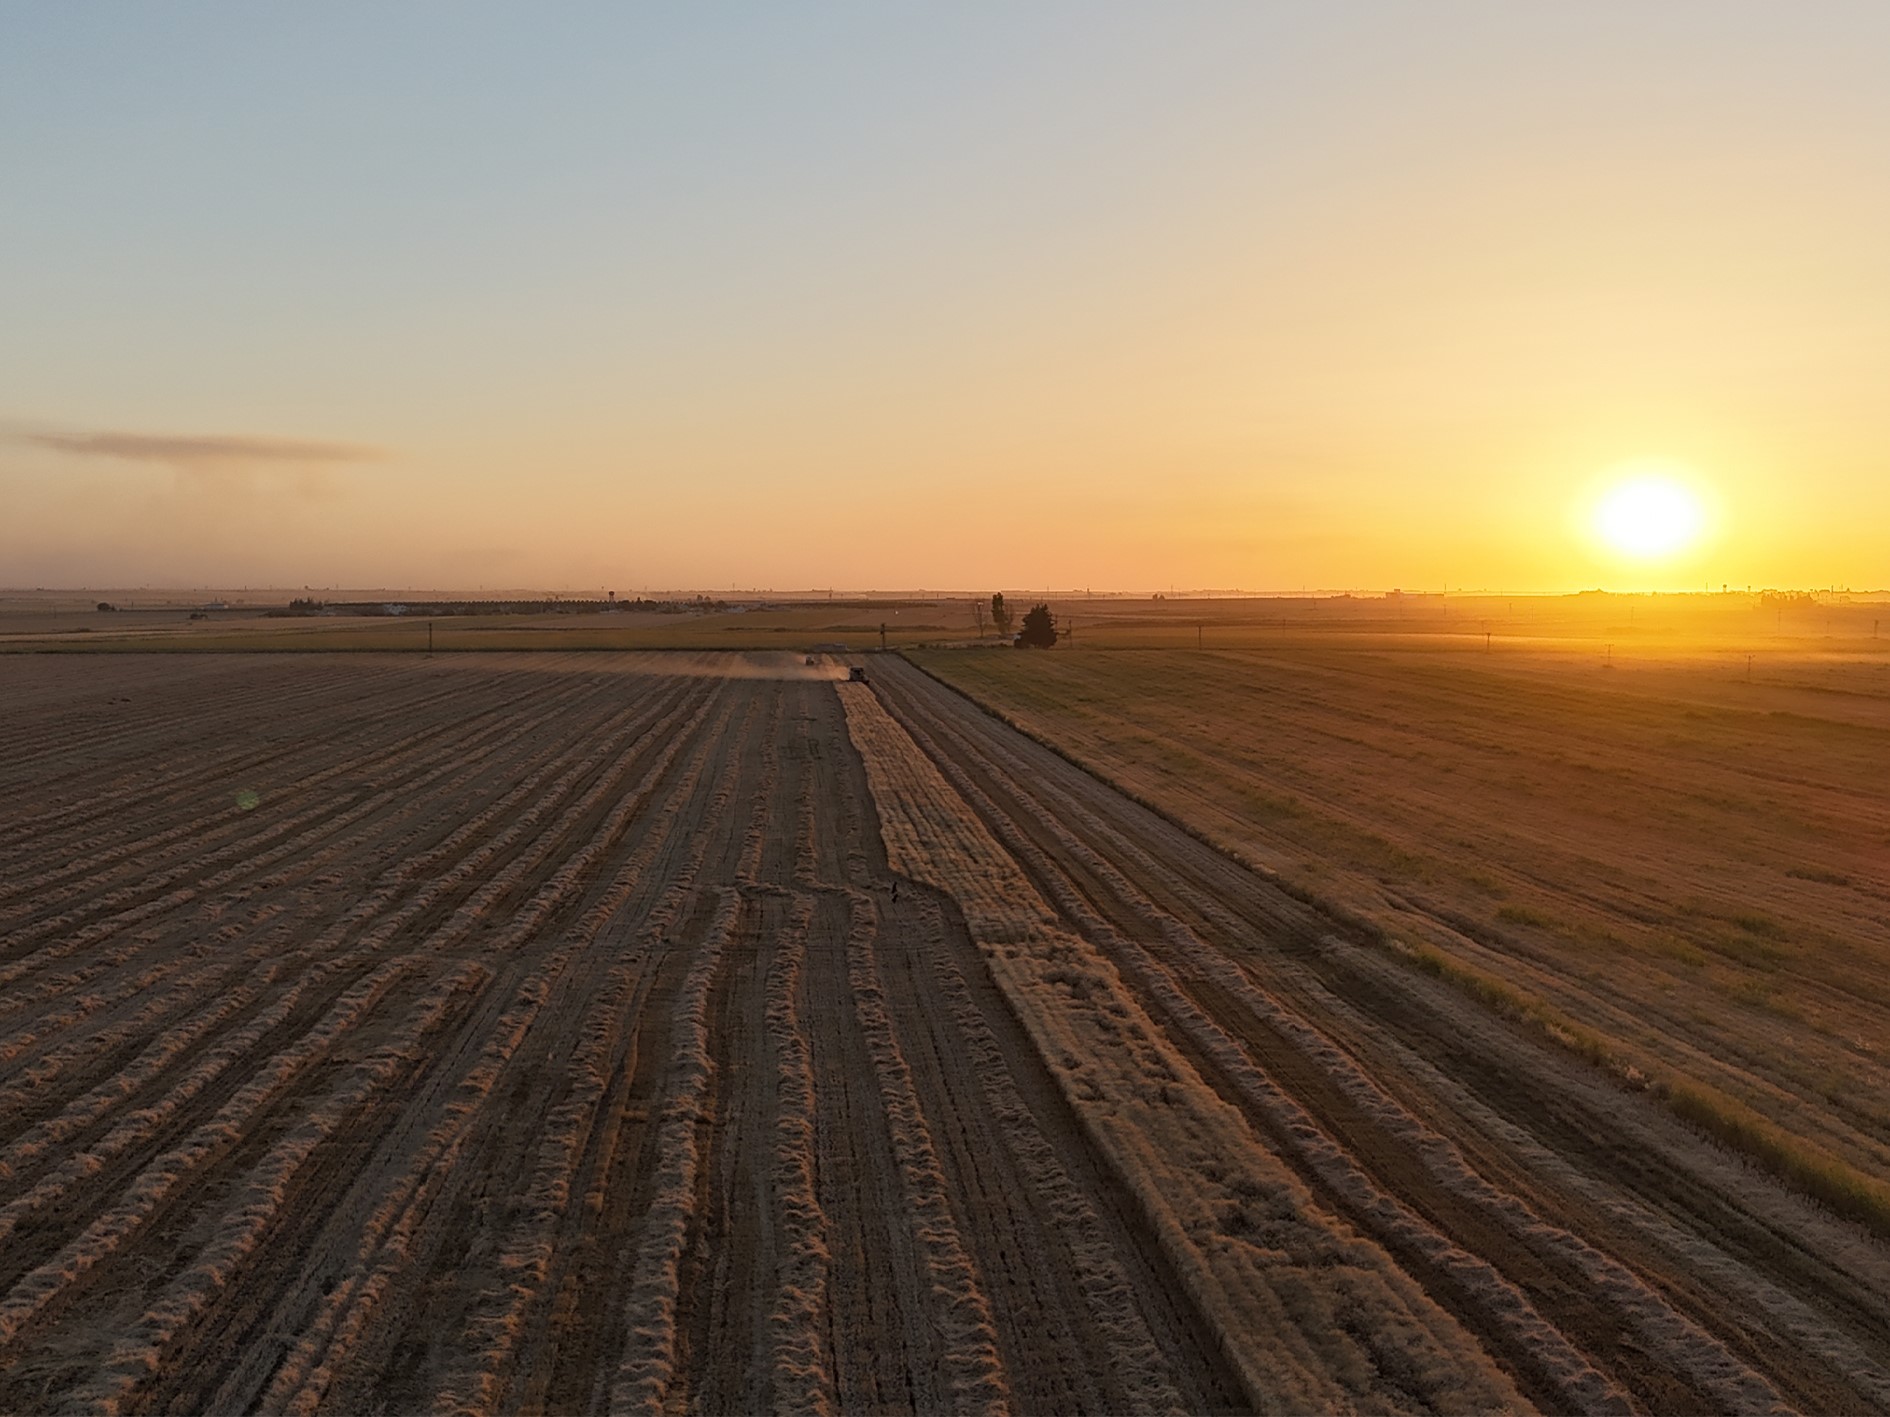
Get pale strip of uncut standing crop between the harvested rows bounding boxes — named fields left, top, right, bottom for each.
left=843, top=690, right=1514, bottom=1408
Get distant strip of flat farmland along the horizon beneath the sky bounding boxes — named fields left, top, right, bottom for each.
left=0, top=591, right=1890, bottom=669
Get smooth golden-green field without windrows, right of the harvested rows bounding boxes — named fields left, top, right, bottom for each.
left=922, top=646, right=1890, bottom=1232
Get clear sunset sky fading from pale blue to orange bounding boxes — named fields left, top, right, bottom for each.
left=0, top=0, right=1890, bottom=593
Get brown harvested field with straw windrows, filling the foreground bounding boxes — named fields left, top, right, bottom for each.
left=0, top=654, right=1890, bottom=1413
